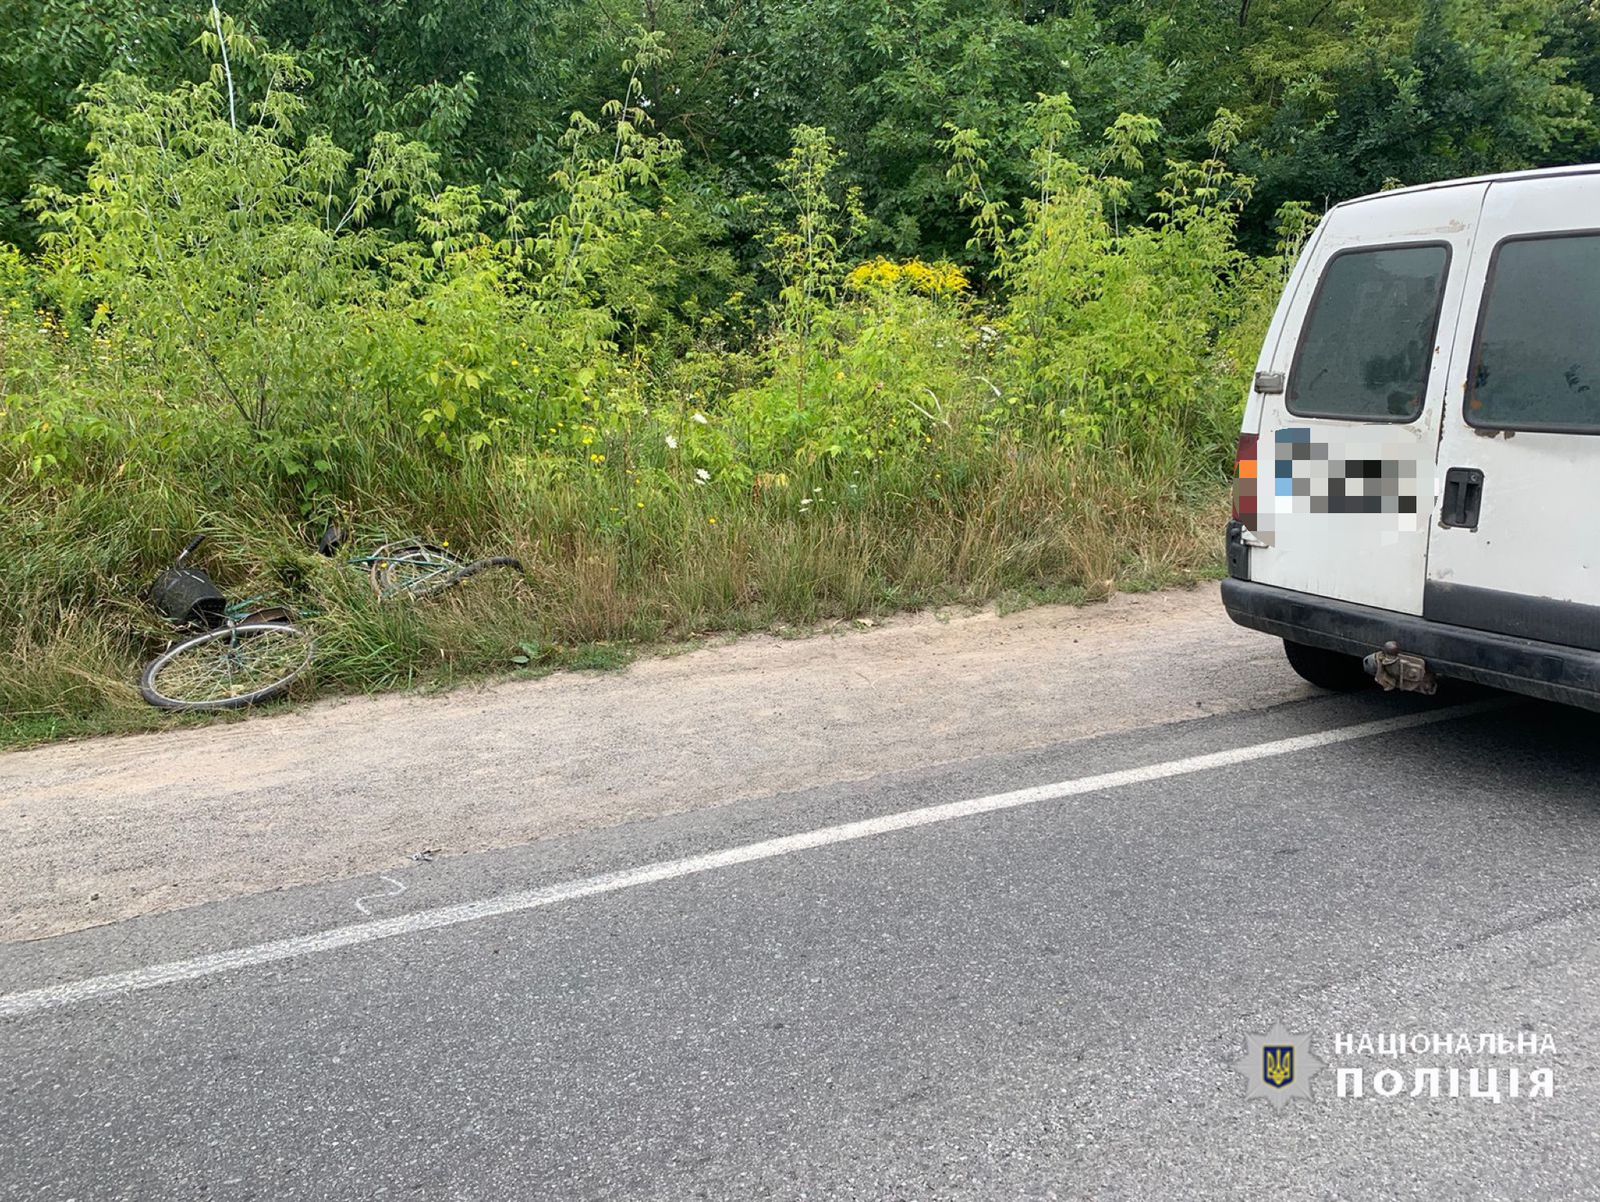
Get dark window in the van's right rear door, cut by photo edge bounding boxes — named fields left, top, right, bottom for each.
left=1467, top=234, right=1600, bottom=434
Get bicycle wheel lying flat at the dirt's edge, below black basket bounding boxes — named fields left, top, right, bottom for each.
left=139, top=623, right=312, bottom=709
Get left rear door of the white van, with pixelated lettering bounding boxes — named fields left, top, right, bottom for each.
left=1246, top=184, right=1486, bottom=613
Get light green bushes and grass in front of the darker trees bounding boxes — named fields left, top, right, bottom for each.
left=0, top=51, right=1273, bottom=738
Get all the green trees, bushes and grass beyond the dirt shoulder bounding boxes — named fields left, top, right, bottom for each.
left=0, top=0, right=1600, bottom=736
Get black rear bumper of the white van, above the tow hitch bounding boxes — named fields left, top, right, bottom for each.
left=1222, top=579, right=1600, bottom=711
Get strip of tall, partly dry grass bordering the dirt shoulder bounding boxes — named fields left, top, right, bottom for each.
left=0, top=412, right=1221, bottom=743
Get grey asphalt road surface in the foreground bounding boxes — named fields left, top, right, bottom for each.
left=0, top=681, right=1600, bottom=1200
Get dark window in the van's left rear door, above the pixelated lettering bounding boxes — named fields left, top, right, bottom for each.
left=1286, top=243, right=1450, bottom=421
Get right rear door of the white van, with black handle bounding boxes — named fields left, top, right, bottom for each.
left=1422, top=174, right=1600, bottom=650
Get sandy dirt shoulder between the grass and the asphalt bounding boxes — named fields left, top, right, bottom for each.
left=0, top=584, right=1309, bottom=941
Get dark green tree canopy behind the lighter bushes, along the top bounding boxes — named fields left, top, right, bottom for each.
left=0, top=0, right=1600, bottom=258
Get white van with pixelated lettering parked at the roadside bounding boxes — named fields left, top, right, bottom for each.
left=1222, top=166, right=1600, bottom=709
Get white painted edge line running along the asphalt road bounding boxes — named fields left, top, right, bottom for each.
left=0, top=699, right=1509, bottom=1018
